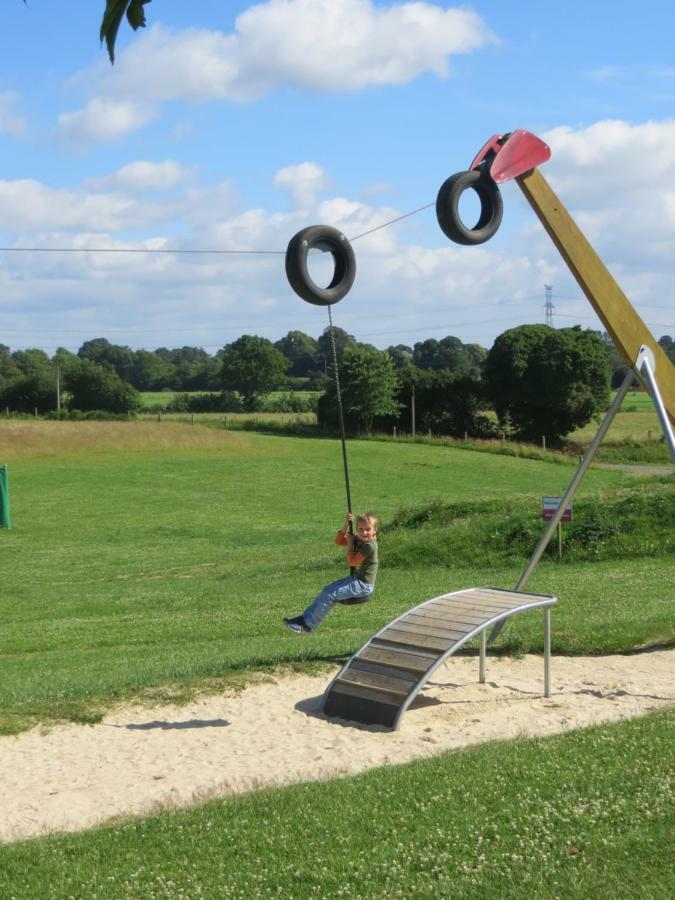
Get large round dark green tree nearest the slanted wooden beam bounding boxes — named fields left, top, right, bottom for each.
left=485, top=325, right=609, bottom=441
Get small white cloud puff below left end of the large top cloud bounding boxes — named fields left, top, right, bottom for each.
left=58, top=97, right=156, bottom=144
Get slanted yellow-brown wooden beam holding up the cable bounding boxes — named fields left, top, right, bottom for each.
left=516, top=168, right=675, bottom=424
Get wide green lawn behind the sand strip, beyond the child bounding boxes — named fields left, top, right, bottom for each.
left=0, top=422, right=675, bottom=731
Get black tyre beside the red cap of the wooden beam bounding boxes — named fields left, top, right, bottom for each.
left=436, top=169, right=504, bottom=244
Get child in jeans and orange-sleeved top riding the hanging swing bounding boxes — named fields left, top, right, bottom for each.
left=284, top=513, right=377, bottom=634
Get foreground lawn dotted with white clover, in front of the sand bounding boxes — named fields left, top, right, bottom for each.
left=0, top=711, right=675, bottom=900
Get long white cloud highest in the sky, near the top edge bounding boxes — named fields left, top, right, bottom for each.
left=59, top=0, right=495, bottom=142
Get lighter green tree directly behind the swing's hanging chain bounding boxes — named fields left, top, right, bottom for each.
left=318, top=344, right=399, bottom=434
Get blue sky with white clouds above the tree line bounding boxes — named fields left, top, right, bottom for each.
left=0, top=0, right=675, bottom=355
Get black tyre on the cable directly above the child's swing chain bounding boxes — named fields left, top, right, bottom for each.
left=286, top=225, right=356, bottom=306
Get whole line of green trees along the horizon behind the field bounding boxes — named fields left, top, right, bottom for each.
left=0, top=325, right=675, bottom=442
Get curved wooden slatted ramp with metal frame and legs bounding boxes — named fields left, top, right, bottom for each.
left=323, top=588, right=556, bottom=729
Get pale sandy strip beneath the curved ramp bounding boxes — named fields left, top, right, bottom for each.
left=0, top=650, right=675, bottom=842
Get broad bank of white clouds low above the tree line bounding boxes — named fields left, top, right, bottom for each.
left=5, top=122, right=675, bottom=351
